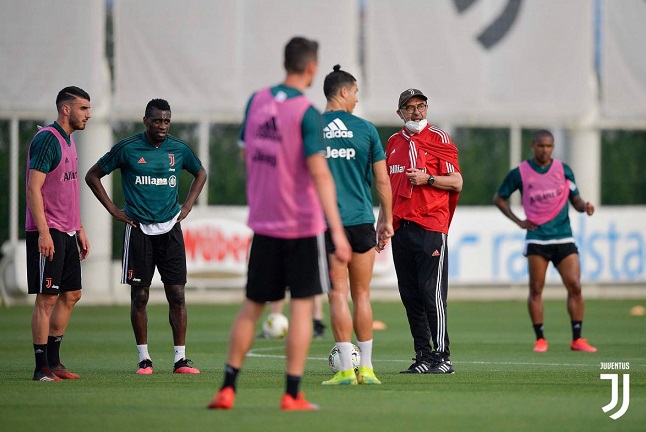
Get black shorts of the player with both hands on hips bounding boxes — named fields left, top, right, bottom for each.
left=121, top=223, right=186, bottom=286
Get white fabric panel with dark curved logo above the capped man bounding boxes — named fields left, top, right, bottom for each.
left=364, top=0, right=596, bottom=124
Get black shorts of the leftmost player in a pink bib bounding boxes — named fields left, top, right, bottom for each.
left=25, top=229, right=81, bottom=294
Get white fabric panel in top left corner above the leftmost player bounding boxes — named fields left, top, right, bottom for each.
left=0, top=0, right=109, bottom=118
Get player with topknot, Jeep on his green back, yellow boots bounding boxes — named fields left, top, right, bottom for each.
left=323, top=65, right=393, bottom=385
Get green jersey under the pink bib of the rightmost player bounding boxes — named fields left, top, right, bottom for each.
left=498, top=159, right=579, bottom=243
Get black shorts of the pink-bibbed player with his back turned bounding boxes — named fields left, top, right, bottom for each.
left=246, top=234, right=330, bottom=303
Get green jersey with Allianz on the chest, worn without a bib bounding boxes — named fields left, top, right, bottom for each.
left=98, top=132, right=202, bottom=224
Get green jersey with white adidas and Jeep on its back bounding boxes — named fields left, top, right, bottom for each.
left=322, top=111, right=386, bottom=226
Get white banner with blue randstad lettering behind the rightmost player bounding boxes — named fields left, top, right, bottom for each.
left=449, top=206, right=646, bottom=285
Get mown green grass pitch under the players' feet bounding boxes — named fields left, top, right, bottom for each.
left=0, top=293, right=646, bottom=432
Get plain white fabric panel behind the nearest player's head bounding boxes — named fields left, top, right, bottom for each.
left=114, top=0, right=359, bottom=121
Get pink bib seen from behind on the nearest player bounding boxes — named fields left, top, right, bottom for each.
left=244, top=88, right=326, bottom=239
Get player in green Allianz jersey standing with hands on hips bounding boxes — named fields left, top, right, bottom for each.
left=85, top=99, right=206, bottom=375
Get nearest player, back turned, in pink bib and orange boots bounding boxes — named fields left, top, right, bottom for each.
left=208, top=37, right=351, bottom=411
